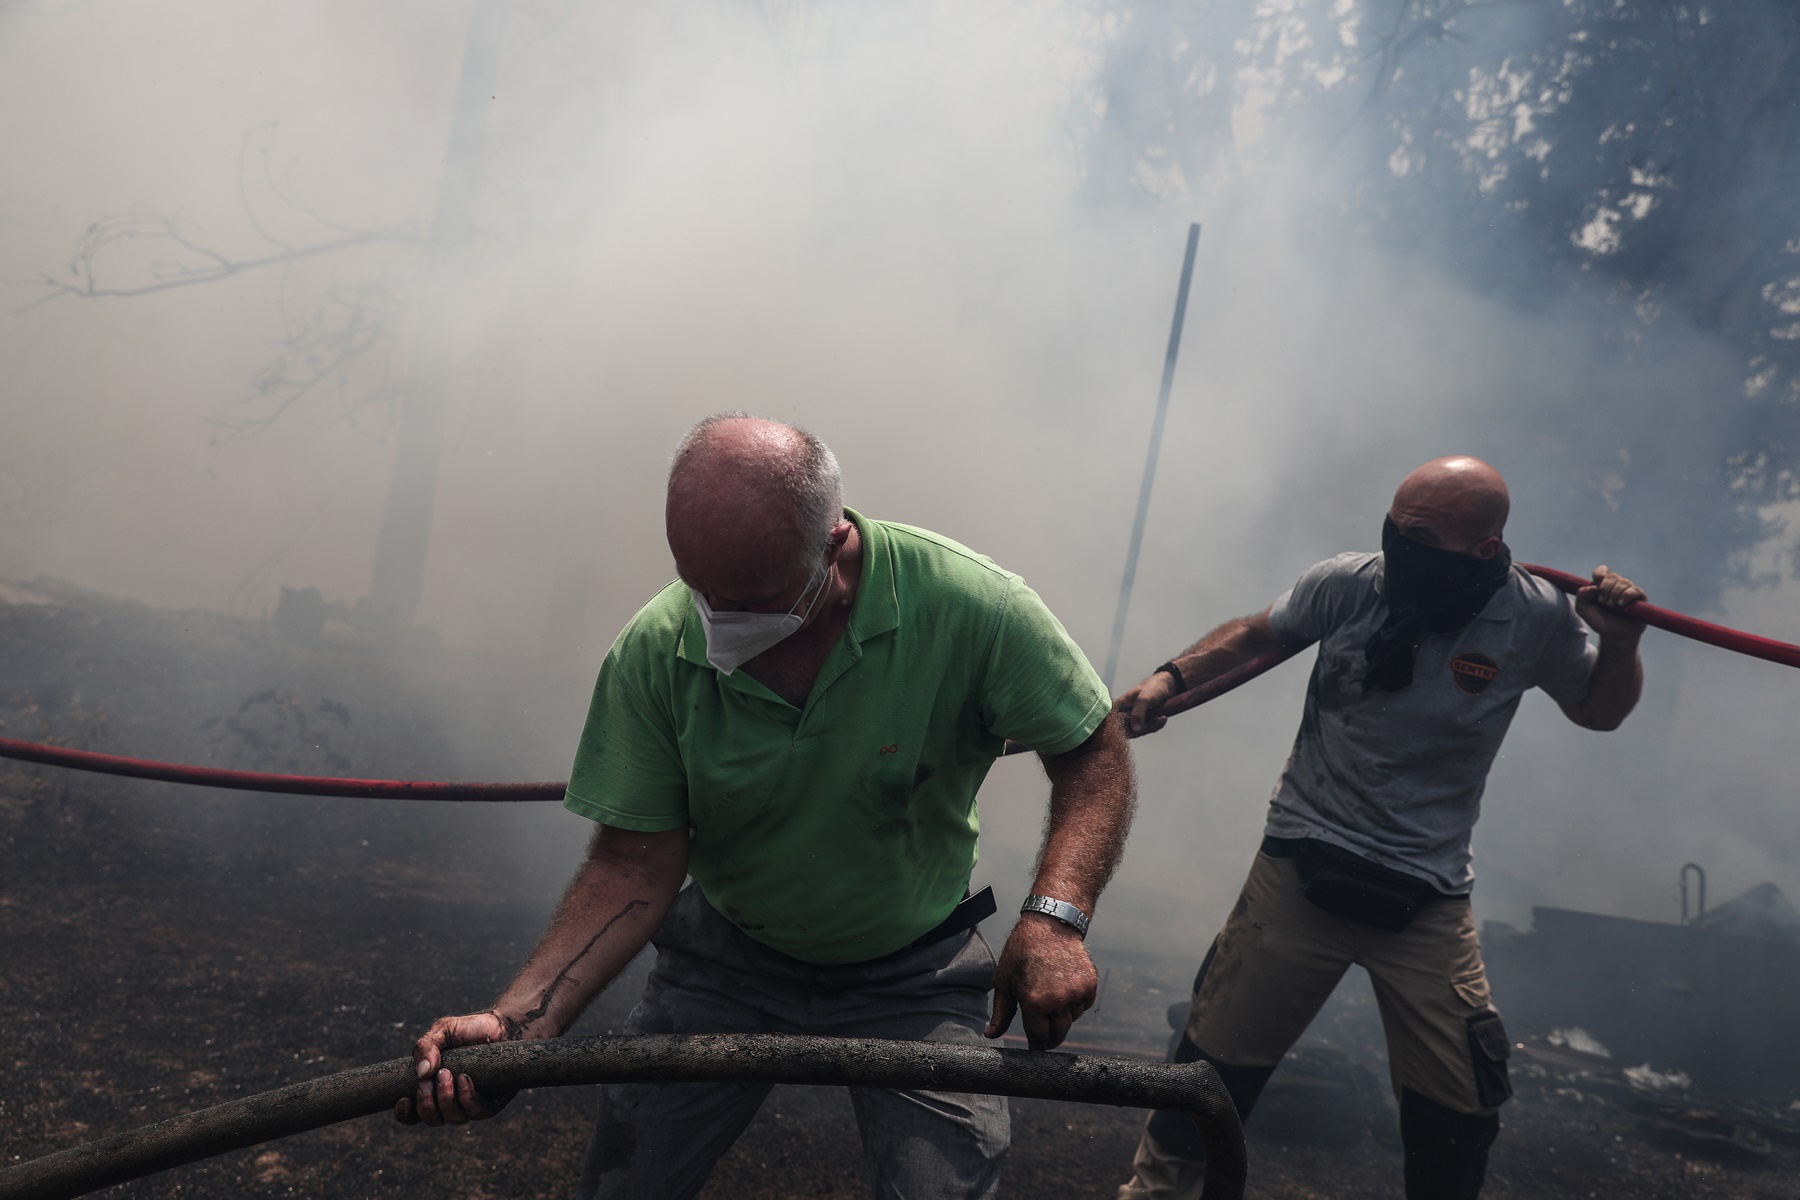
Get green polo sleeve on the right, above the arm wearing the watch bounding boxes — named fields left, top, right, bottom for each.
left=979, top=576, right=1112, bottom=754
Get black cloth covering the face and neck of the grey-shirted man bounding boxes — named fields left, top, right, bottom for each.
left=1363, top=520, right=1512, bottom=691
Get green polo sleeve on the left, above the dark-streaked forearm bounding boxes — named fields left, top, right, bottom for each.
left=563, top=639, right=688, bottom=833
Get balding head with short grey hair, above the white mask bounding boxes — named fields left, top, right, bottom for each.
left=664, top=412, right=844, bottom=606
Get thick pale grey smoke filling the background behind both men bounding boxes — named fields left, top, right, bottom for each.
left=0, top=0, right=1800, bottom=950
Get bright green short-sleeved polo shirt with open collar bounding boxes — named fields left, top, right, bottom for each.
left=563, top=509, right=1111, bottom=963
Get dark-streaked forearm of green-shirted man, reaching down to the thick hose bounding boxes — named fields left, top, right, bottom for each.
left=493, top=829, right=688, bottom=1040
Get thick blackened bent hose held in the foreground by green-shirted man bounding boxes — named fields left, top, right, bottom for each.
left=0, top=1033, right=1244, bottom=1200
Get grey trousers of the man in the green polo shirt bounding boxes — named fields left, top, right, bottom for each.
left=576, top=887, right=1012, bottom=1200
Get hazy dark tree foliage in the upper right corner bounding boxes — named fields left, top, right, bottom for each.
left=1087, top=0, right=1800, bottom=603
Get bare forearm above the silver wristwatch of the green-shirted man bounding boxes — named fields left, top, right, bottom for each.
left=1031, top=716, right=1138, bottom=912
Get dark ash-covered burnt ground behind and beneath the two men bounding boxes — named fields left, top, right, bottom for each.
left=0, top=581, right=1800, bottom=1200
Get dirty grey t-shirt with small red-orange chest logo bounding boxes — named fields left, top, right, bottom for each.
left=1267, top=554, right=1597, bottom=892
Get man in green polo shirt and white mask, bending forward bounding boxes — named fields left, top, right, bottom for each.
left=396, top=414, right=1134, bottom=1200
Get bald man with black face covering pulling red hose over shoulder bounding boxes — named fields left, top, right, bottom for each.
left=1116, top=457, right=1643, bottom=1200
